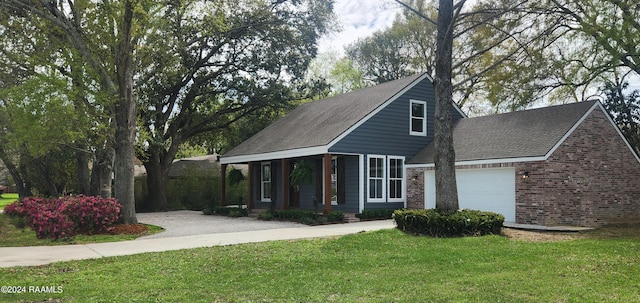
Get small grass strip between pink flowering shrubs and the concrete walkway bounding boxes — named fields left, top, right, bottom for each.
left=0, top=214, right=163, bottom=248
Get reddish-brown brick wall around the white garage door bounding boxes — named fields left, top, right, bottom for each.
left=407, top=109, right=640, bottom=226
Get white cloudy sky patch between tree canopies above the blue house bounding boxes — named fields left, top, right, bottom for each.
left=319, top=0, right=400, bottom=53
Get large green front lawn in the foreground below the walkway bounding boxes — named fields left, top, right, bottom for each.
left=0, top=229, right=640, bottom=302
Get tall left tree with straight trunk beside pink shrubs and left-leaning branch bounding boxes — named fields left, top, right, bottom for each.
left=0, top=0, right=153, bottom=223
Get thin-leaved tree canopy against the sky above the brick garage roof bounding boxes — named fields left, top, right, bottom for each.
left=347, top=0, right=640, bottom=113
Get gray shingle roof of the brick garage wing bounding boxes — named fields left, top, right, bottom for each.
left=408, top=101, right=597, bottom=164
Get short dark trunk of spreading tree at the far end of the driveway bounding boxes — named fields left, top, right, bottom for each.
left=144, top=152, right=169, bottom=211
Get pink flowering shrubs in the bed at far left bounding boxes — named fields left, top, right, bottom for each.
left=5, top=195, right=122, bottom=239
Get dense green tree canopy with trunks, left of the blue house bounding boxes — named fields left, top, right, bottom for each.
left=0, top=0, right=333, bottom=214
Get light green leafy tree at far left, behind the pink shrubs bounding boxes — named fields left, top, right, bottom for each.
left=0, top=5, right=120, bottom=201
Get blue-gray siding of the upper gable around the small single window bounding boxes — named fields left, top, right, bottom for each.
left=329, top=79, right=462, bottom=159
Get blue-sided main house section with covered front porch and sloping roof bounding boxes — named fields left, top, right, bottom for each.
left=220, top=74, right=464, bottom=213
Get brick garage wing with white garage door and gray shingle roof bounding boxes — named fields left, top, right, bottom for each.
left=407, top=101, right=640, bottom=226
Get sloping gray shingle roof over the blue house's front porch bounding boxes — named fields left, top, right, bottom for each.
left=223, top=75, right=423, bottom=158
